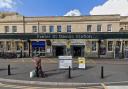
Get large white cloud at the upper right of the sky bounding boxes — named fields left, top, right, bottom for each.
left=90, top=0, right=128, bottom=16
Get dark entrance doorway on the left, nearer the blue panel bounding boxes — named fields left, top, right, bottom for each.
left=53, top=46, right=66, bottom=57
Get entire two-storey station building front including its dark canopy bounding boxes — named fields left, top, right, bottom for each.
left=0, top=12, right=128, bottom=58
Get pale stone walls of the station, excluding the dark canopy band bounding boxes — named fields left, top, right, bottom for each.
left=0, top=12, right=128, bottom=58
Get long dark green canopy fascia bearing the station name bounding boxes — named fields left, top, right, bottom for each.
left=0, top=32, right=128, bottom=40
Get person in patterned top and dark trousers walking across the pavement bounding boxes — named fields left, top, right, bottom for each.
left=32, top=54, right=44, bottom=77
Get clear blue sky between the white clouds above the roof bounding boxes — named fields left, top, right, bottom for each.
left=18, top=0, right=106, bottom=16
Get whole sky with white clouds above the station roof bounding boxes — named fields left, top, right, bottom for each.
left=0, top=0, right=128, bottom=16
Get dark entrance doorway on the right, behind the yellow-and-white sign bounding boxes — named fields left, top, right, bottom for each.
left=71, top=45, right=84, bottom=57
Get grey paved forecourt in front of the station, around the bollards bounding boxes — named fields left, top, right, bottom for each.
left=0, top=58, right=128, bottom=89
